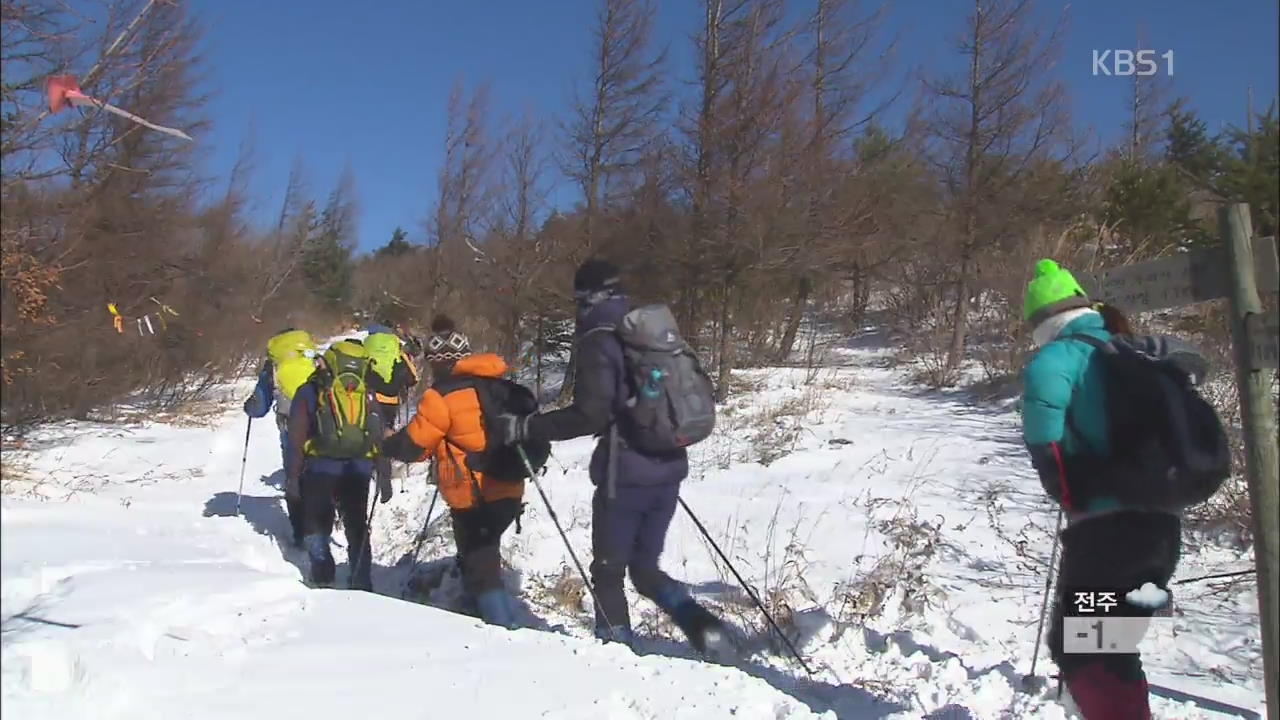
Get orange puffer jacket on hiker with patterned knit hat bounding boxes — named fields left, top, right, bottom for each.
left=404, top=354, right=525, bottom=510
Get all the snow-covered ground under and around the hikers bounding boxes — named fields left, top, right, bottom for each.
left=0, top=333, right=1263, bottom=720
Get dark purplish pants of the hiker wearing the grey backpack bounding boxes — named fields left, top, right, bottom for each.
left=591, top=483, right=689, bottom=630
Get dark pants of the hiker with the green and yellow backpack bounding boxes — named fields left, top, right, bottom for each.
left=301, top=471, right=372, bottom=589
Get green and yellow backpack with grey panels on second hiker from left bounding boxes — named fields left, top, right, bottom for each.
left=307, top=341, right=381, bottom=459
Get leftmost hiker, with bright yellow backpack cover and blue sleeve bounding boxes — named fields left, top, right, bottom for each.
left=244, top=328, right=316, bottom=547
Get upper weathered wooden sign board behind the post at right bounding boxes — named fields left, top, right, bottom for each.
left=1076, top=237, right=1280, bottom=313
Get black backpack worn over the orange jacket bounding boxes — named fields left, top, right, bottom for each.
left=433, top=375, right=552, bottom=483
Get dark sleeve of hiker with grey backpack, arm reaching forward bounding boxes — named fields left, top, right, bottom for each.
left=527, top=333, right=622, bottom=442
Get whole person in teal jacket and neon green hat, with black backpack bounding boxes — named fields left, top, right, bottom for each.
left=1023, top=260, right=1230, bottom=720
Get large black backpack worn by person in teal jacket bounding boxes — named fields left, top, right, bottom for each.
left=1068, top=334, right=1231, bottom=510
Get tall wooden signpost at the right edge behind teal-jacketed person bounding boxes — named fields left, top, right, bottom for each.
left=1219, top=204, right=1280, bottom=720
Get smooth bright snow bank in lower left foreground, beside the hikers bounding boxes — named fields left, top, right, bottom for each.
left=0, top=394, right=829, bottom=719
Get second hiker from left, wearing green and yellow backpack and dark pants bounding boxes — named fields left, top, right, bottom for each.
left=284, top=341, right=392, bottom=591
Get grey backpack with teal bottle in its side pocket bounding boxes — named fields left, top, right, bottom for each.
left=600, top=305, right=716, bottom=454
